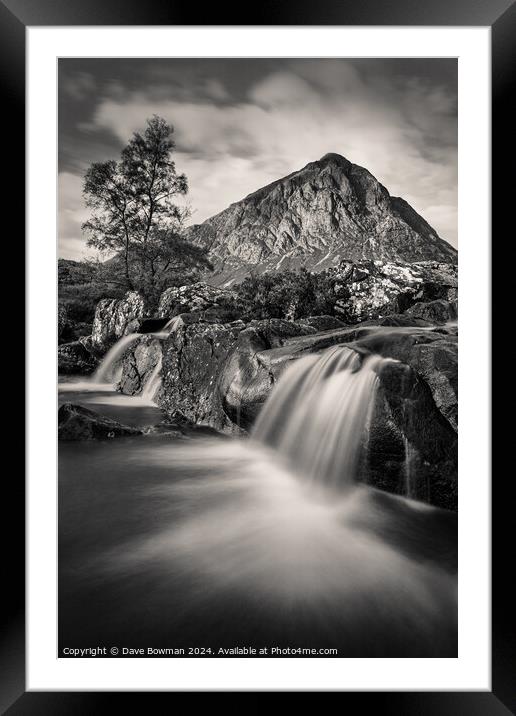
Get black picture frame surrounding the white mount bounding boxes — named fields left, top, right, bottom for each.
left=0, top=0, right=516, bottom=716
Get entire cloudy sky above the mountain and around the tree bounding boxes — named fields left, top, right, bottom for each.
left=58, top=58, right=457, bottom=259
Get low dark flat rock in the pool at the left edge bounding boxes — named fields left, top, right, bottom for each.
left=58, top=403, right=142, bottom=440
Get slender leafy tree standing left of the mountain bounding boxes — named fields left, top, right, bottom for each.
left=83, top=115, right=209, bottom=297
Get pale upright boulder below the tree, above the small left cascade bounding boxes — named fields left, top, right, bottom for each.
left=91, top=291, right=145, bottom=351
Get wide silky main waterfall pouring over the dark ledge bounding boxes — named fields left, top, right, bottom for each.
left=252, top=346, right=384, bottom=487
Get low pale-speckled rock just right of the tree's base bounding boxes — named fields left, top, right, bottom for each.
left=158, top=282, right=238, bottom=322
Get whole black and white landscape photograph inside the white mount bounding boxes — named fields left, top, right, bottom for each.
left=56, top=57, right=461, bottom=659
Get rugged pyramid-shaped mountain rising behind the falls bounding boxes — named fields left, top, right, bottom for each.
left=186, top=154, right=457, bottom=285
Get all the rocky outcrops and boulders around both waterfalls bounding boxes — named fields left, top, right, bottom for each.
left=59, top=261, right=458, bottom=509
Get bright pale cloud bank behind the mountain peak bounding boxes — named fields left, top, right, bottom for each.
left=58, top=60, right=457, bottom=255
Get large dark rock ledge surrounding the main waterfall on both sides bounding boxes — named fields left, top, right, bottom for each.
left=153, top=314, right=457, bottom=509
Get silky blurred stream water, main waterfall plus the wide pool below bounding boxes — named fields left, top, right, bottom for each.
left=59, top=338, right=457, bottom=657
